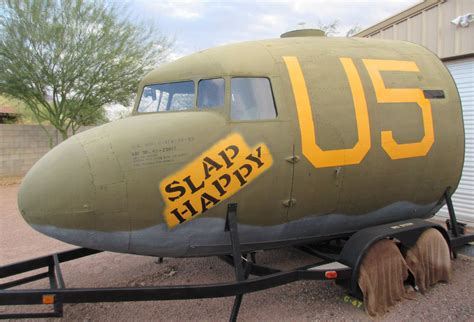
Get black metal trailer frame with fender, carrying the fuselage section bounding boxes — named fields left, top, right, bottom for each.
left=0, top=190, right=474, bottom=321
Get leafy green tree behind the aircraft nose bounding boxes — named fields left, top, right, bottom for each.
left=0, top=0, right=172, bottom=143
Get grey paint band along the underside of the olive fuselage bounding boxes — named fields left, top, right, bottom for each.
left=33, top=202, right=441, bottom=257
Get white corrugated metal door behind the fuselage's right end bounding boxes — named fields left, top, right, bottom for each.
left=438, top=58, right=474, bottom=223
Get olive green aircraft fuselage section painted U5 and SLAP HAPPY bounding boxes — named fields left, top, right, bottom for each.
left=19, top=37, right=464, bottom=256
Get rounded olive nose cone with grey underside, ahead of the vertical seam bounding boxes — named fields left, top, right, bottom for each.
left=18, top=128, right=130, bottom=252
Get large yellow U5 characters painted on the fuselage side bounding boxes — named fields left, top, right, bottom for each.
left=283, top=56, right=435, bottom=168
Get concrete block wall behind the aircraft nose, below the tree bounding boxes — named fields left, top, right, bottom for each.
left=0, top=124, right=92, bottom=177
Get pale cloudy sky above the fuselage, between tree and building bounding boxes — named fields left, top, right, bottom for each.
left=130, top=0, right=421, bottom=59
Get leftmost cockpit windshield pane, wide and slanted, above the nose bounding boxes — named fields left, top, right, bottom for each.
left=138, top=81, right=194, bottom=113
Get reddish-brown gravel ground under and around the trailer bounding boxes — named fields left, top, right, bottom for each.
left=0, top=182, right=474, bottom=321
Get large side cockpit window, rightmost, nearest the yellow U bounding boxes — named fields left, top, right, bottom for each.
left=230, top=77, right=277, bottom=120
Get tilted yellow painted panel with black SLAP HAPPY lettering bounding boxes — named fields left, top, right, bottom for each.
left=160, top=133, right=273, bottom=228
